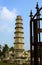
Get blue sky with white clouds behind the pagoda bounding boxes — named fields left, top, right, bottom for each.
left=0, top=0, right=42, bottom=50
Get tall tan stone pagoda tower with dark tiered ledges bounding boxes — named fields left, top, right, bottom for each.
left=14, top=16, right=24, bottom=62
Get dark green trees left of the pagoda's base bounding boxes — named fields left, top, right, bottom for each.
left=0, top=44, right=14, bottom=59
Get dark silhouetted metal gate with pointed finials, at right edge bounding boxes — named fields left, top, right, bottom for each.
left=30, top=3, right=42, bottom=65
